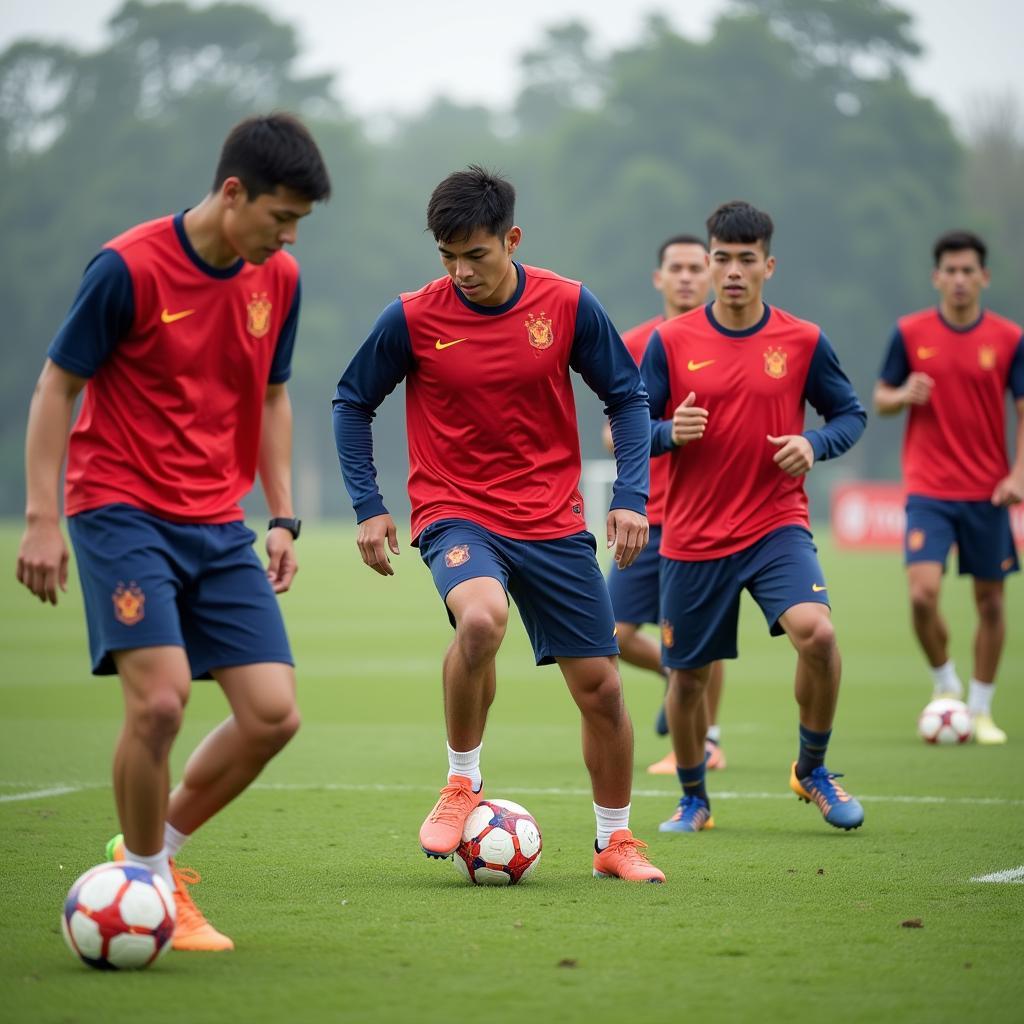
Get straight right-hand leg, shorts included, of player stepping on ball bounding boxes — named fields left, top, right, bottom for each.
left=509, top=530, right=665, bottom=882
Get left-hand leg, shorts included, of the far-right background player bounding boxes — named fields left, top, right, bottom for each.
left=903, top=495, right=964, bottom=698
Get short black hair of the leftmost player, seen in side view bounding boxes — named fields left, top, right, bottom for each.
left=213, top=112, right=331, bottom=203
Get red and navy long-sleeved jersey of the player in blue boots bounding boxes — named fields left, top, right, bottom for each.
left=640, top=305, right=867, bottom=561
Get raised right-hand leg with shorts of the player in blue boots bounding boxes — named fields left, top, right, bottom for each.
left=743, top=526, right=864, bottom=830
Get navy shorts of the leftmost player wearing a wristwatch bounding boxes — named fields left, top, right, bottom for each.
left=68, top=505, right=295, bottom=679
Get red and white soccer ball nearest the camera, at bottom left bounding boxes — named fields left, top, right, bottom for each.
left=60, top=861, right=176, bottom=971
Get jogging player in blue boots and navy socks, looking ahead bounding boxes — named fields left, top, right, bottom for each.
left=641, top=202, right=866, bottom=833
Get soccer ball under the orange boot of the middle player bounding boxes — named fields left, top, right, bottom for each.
left=454, top=800, right=541, bottom=886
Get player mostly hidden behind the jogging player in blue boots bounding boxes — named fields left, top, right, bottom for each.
left=604, top=234, right=725, bottom=775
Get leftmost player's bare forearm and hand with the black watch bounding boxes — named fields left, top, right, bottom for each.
left=259, top=384, right=299, bottom=594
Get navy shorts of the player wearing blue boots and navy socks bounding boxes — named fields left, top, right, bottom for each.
left=662, top=526, right=828, bottom=669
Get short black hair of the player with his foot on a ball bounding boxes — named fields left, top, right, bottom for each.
left=427, top=164, right=515, bottom=242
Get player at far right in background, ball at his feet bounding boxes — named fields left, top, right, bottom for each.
left=874, top=231, right=1024, bottom=743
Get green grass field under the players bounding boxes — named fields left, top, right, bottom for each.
left=0, top=525, right=1024, bottom=1024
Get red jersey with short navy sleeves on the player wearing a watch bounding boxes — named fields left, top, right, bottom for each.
left=48, top=214, right=299, bottom=523
